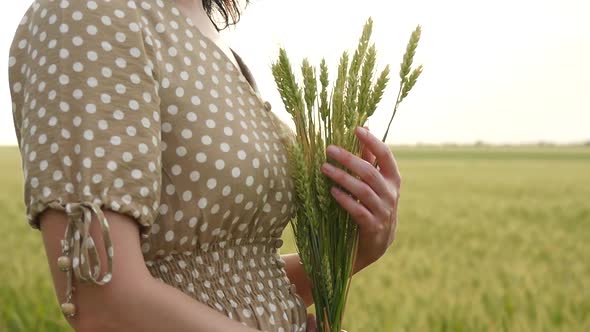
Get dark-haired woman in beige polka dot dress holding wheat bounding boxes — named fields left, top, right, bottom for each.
left=9, top=0, right=401, bottom=332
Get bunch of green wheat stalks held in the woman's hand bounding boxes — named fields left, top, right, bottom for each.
left=272, top=18, right=422, bottom=332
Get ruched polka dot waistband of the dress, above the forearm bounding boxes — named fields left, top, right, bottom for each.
left=146, top=238, right=296, bottom=311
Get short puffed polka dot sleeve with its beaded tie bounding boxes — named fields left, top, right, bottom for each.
left=9, top=0, right=161, bottom=316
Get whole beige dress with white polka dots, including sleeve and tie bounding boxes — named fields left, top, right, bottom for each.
left=9, top=0, right=306, bottom=331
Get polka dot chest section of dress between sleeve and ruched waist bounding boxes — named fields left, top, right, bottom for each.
left=150, top=31, right=294, bottom=237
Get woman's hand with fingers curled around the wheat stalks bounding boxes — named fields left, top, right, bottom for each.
left=321, top=127, right=401, bottom=273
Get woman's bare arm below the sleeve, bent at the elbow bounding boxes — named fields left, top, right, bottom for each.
left=40, top=209, right=255, bottom=332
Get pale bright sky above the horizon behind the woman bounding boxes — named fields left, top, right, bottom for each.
left=0, top=0, right=590, bottom=145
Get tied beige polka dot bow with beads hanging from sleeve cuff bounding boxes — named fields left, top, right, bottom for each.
left=57, top=202, right=114, bottom=317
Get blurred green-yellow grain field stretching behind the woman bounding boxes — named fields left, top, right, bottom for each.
left=0, top=147, right=590, bottom=332
